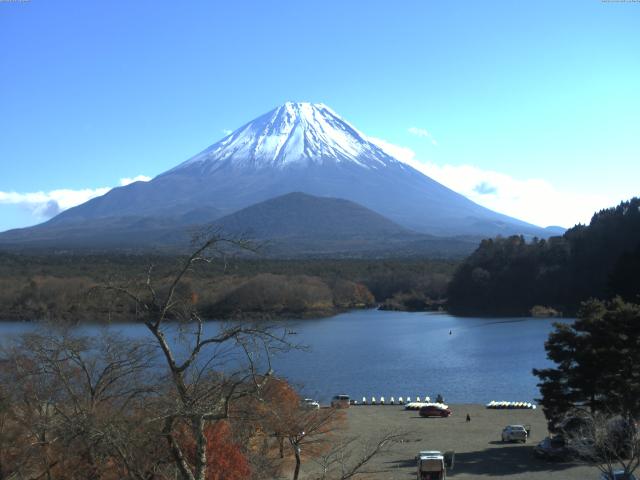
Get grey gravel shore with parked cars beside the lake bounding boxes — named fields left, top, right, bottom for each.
left=303, top=404, right=599, bottom=480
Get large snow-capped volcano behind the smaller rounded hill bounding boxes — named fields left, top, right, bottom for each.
left=0, top=102, right=550, bottom=253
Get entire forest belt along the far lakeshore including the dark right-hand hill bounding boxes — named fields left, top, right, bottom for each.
left=6, top=198, right=640, bottom=321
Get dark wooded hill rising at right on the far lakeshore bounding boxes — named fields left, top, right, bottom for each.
left=448, top=198, right=640, bottom=315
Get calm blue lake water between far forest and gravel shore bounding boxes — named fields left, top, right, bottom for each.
left=0, top=310, right=566, bottom=403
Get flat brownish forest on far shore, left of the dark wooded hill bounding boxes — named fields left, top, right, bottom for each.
left=0, top=253, right=455, bottom=321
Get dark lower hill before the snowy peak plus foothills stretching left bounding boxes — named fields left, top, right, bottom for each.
left=4, top=192, right=479, bottom=258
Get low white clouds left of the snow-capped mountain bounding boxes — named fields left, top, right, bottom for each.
left=0, top=175, right=151, bottom=220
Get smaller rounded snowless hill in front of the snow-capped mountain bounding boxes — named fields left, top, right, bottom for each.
left=214, top=192, right=477, bottom=257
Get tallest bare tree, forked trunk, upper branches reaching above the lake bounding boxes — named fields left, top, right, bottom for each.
left=106, top=234, right=296, bottom=480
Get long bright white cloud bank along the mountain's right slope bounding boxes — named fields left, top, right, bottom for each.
left=369, top=137, right=623, bottom=227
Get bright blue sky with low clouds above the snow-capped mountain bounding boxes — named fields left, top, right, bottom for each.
left=0, top=0, right=640, bottom=230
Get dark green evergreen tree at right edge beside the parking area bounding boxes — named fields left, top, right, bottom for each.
left=533, top=298, right=640, bottom=431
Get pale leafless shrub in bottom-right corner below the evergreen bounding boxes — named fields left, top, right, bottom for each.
left=562, top=410, right=640, bottom=478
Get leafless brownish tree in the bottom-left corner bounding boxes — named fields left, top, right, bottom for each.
left=0, top=332, right=159, bottom=480
